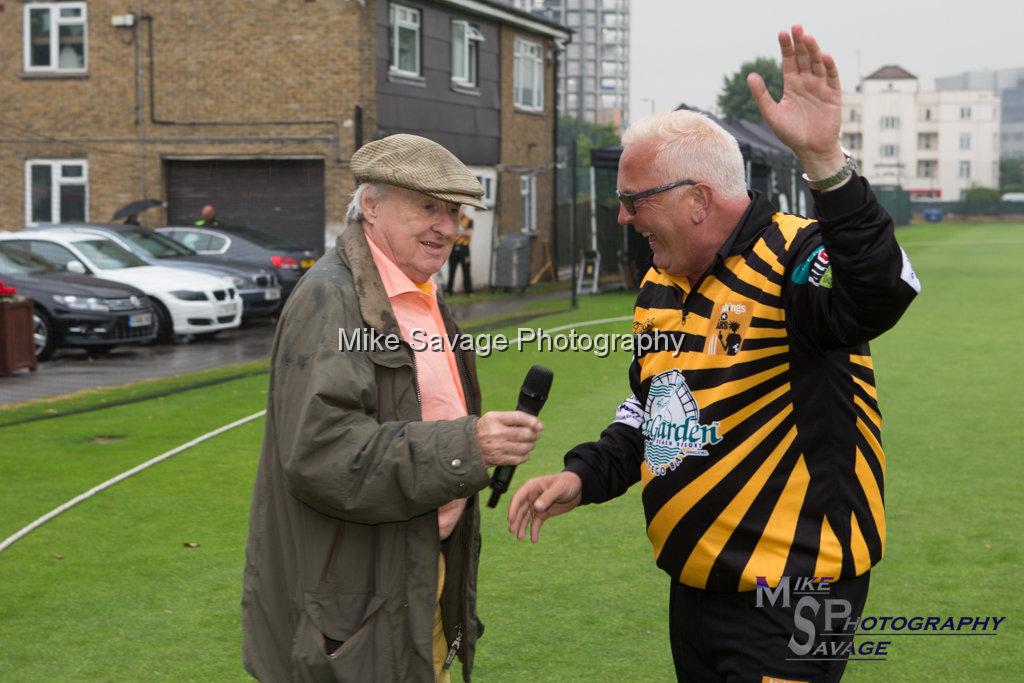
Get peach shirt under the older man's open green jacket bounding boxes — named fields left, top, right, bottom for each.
left=367, top=234, right=468, bottom=420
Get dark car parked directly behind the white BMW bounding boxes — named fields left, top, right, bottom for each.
left=25, top=223, right=282, bottom=319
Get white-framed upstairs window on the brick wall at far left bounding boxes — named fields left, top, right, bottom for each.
left=25, top=2, right=86, bottom=74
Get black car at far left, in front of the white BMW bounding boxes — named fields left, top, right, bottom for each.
left=0, top=243, right=157, bottom=360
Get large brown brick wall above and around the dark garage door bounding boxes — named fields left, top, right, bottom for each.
left=0, top=0, right=376, bottom=240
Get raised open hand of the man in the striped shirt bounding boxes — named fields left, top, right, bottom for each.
left=746, top=24, right=845, bottom=179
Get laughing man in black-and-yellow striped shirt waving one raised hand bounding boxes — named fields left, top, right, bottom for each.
left=509, top=26, right=921, bottom=681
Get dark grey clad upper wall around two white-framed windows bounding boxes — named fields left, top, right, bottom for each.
left=376, top=0, right=501, bottom=166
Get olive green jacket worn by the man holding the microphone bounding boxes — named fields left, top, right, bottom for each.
left=242, top=224, right=488, bottom=683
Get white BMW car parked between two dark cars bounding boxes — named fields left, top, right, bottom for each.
left=0, top=230, right=242, bottom=341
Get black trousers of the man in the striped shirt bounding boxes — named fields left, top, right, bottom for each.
left=669, top=572, right=870, bottom=683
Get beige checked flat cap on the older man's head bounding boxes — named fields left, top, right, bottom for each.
left=352, top=133, right=487, bottom=210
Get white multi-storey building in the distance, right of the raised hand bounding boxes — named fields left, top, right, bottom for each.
left=843, top=79, right=999, bottom=200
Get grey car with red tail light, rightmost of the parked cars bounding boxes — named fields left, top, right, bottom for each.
left=156, top=225, right=317, bottom=299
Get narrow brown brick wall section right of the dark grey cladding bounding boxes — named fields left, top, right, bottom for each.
left=497, top=27, right=555, bottom=272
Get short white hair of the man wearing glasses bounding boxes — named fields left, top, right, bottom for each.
left=623, top=110, right=746, bottom=199
